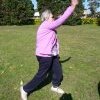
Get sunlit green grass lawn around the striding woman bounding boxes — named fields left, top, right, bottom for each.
left=0, top=25, right=100, bottom=100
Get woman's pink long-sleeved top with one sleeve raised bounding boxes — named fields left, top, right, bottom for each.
left=36, top=6, right=74, bottom=57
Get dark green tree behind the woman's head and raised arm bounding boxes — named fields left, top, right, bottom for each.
left=37, top=0, right=84, bottom=25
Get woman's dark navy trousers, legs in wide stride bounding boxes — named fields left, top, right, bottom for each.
left=23, top=56, right=62, bottom=93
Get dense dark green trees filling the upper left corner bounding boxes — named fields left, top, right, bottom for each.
left=0, top=0, right=34, bottom=25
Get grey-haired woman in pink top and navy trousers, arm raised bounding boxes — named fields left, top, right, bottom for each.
left=20, top=0, right=78, bottom=100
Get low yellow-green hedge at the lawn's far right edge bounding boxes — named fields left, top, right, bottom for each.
left=82, top=18, right=100, bottom=26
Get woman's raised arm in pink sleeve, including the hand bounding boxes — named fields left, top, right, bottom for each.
left=48, top=0, right=78, bottom=29
